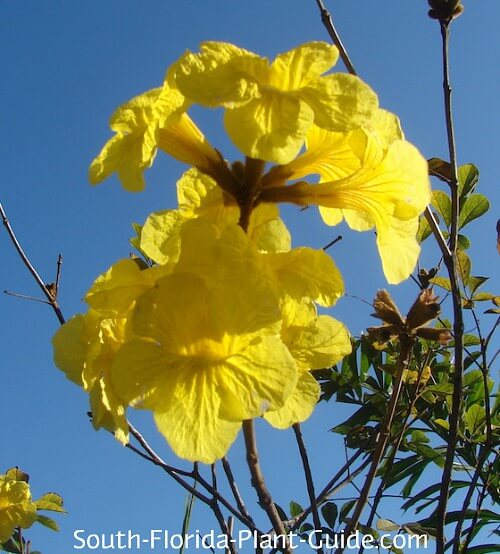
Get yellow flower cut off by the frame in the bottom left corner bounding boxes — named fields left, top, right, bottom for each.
left=0, top=475, right=37, bottom=543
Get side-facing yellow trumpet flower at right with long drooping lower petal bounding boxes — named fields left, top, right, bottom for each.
left=263, top=133, right=431, bottom=284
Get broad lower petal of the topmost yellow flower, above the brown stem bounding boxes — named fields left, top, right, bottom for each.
left=224, top=91, right=314, bottom=164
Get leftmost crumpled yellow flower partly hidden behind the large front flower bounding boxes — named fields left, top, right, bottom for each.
left=52, top=259, right=169, bottom=444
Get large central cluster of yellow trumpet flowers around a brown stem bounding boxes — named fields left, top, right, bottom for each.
left=54, top=42, right=430, bottom=463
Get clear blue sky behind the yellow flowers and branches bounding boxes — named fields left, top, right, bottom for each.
left=0, top=0, right=500, bottom=553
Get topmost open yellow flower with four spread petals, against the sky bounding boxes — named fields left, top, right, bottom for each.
left=176, top=42, right=378, bottom=164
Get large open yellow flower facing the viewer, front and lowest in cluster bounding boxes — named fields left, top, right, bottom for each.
left=112, top=270, right=297, bottom=463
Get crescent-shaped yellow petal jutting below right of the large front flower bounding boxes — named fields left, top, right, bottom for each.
left=264, top=371, right=320, bottom=429
